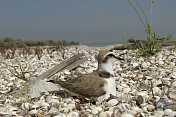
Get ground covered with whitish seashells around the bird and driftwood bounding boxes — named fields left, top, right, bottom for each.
left=0, top=46, right=176, bottom=117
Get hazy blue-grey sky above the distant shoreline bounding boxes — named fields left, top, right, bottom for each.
left=0, top=0, right=176, bottom=43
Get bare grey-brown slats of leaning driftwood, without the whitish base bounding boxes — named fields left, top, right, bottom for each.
left=37, top=54, right=87, bottom=79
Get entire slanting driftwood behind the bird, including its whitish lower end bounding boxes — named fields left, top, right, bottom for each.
left=13, top=54, right=87, bottom=98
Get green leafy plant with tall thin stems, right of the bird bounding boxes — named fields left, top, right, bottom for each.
left=127, top=0, right=173, bottom=56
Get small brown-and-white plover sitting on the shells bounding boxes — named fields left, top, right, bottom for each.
left=57, top=50, right=123, bottom=101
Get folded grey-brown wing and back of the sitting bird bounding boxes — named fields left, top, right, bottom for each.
left=57, top=73, right=106, bottom=98
